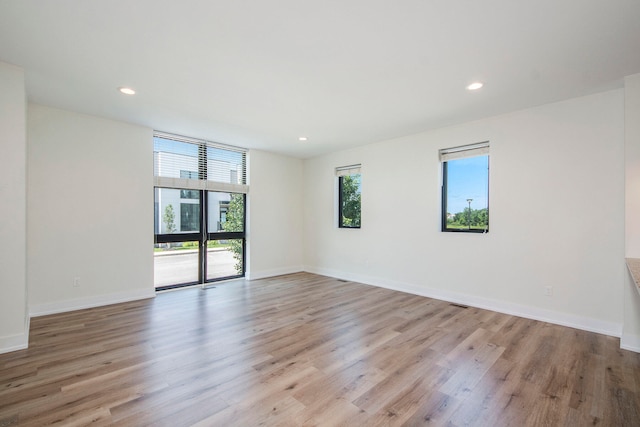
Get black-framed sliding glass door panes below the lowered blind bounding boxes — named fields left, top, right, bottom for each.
left=154, top=188, right=245, bottom=289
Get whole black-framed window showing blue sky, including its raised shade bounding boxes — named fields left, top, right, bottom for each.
left=440, top=142, right=489, bottom=233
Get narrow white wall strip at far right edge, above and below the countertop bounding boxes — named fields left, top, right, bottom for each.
left=621, top=74, right=640, bottom=352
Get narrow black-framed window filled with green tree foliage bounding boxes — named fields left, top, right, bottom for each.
left=336, top=165, right=362, bottom=228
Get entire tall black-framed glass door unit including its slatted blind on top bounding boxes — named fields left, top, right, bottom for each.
left=153, top=132, right=249, bottom=290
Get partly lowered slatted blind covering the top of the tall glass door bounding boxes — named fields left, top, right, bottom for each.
left=153, top=132, right=249, bottom=193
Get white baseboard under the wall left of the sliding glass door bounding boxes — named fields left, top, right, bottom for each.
left=29, top=289, right=156, bottom=317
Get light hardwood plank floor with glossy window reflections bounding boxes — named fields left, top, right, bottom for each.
left=0, top=273, right=640, bottom=427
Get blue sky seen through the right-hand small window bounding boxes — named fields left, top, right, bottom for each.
left=447, top=156, right=489, bottom=214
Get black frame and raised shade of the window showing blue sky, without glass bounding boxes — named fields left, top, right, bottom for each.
left=439, top=141, right=491, bottom=234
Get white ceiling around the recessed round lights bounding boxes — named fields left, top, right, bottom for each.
left=0, top=0, right=640, bottom=158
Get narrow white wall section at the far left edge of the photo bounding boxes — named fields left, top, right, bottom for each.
left=0, top=62, right=29, bottom=353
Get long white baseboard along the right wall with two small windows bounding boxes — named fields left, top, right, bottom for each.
left=305, top=266, right=622, bottom=338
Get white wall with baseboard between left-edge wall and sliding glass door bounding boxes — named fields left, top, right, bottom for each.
left=27, top=105, right=155, bottom=315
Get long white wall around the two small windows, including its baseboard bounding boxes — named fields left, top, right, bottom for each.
left=304, top=90, right=626, bottom=336
